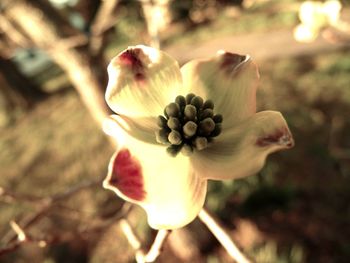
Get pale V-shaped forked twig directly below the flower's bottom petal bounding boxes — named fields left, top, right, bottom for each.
left=120, top=218, right=170, bottom=263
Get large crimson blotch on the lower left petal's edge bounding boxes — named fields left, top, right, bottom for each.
left=108, top=149, right=146, bottom=201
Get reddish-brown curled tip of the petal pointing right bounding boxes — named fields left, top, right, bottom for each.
left=256, top=128, right=294, bottom=148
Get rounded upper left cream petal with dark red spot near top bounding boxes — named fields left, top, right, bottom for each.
left=106, top=45, right=182, bottom=117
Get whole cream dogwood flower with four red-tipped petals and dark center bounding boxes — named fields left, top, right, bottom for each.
left=103, top=45, right=294, bottom=229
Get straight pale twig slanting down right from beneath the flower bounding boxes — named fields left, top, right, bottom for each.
left=198, top=208, right=251, bottom=263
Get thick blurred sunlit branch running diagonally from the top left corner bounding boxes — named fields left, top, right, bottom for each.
left=4, top=0, right=109, bottom=123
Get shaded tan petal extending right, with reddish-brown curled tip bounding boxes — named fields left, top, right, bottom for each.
left=191, top=111, right=294, bottom=180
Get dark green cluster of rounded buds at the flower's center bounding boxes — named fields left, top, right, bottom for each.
left=156, top=93, right=222, bottom=156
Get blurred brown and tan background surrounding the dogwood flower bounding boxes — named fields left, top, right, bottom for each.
left=0, top=0, right=350, bottom=263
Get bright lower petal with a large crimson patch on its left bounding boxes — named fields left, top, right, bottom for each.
left=103, top=127, right=207, bottom=229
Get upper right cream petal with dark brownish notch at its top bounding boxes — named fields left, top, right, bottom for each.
left=181, top=51, right=259, bottom=129
